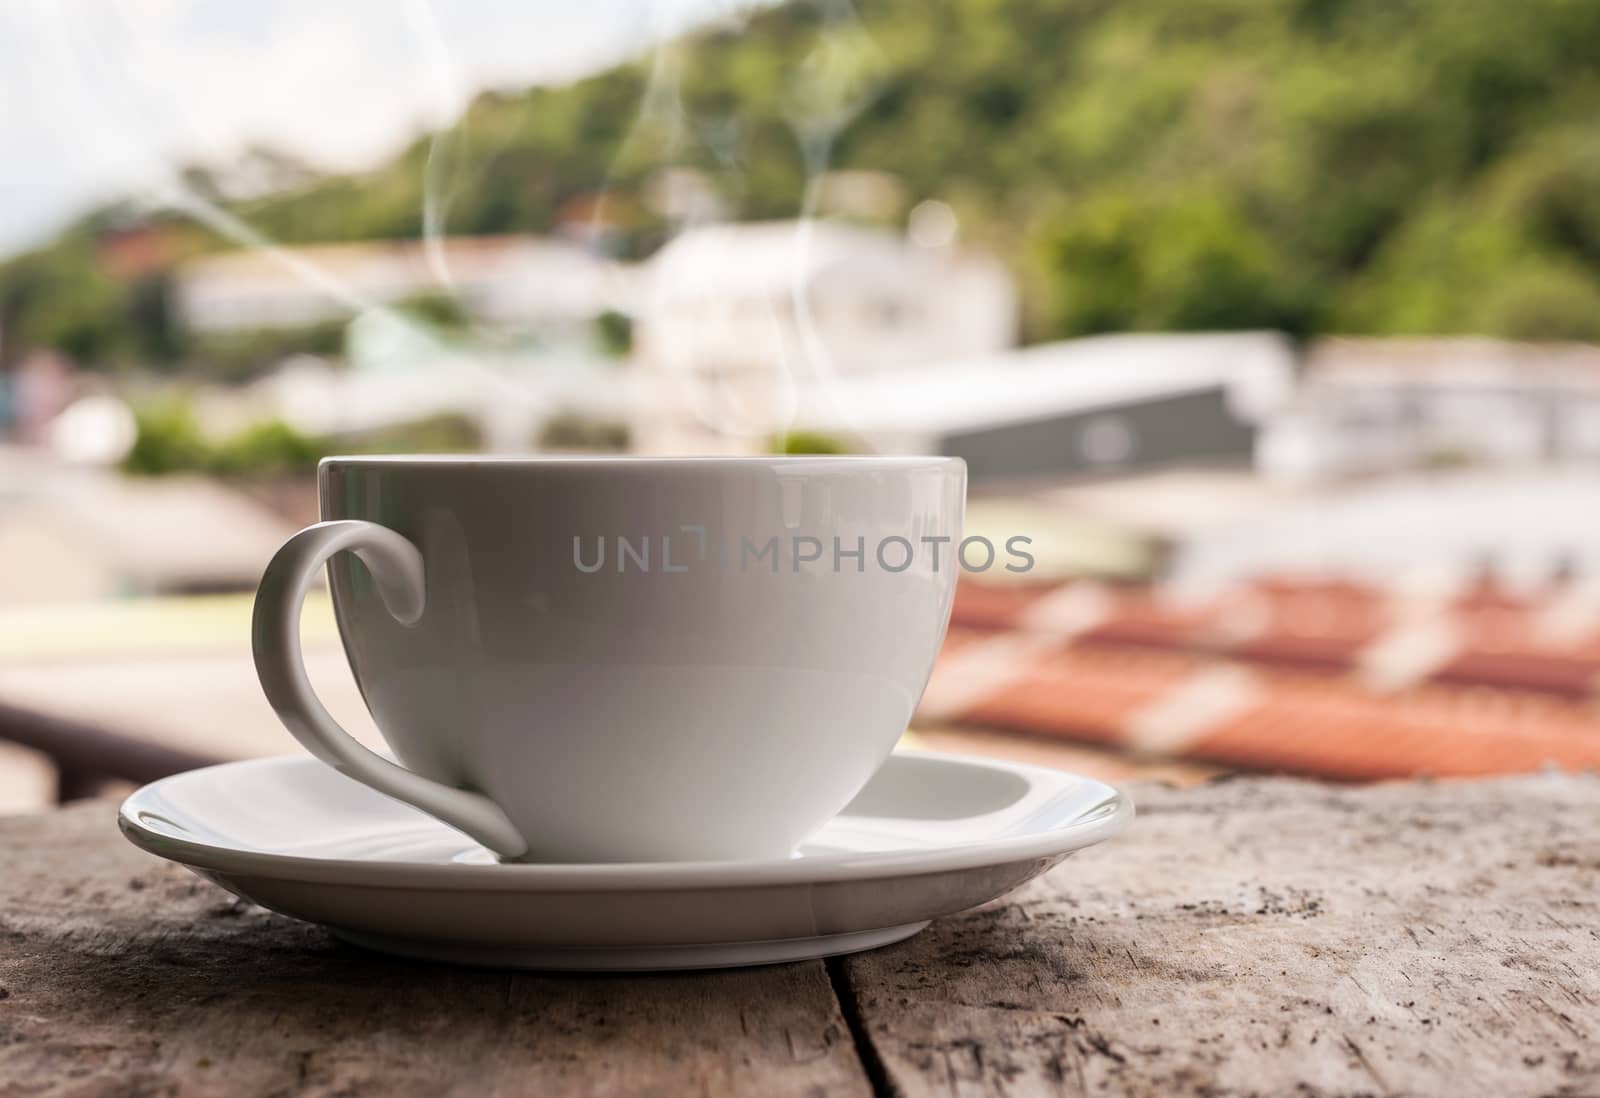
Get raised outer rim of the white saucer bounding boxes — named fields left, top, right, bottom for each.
left=117, top=751, right=1134, bottom=892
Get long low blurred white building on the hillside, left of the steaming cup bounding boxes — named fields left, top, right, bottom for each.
left=178, top=235, right=610, bottom=342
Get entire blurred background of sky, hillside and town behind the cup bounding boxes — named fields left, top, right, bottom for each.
left=0, top=0, right=1600, bottom=811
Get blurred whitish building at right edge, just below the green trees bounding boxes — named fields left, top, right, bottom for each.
left=1261, top=339, right=1600, bottom=480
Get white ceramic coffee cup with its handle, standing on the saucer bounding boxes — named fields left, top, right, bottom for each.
left=253, top=456, right=966, bottom=861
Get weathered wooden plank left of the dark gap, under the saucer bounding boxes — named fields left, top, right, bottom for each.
left=0, top=802, right=870, bottom=1098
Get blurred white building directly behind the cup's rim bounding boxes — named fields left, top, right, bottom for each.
left=634, top=221, right=1018, bottom=453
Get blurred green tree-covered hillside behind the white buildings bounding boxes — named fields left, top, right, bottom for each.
left=0, top=0, right=1600, bottom=365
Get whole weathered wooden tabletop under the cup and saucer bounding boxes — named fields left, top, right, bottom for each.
left=0, top=775, right=1600, bottom=1098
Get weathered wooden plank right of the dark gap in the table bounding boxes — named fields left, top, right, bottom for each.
left=840, top=776, right=1600, bottom=1096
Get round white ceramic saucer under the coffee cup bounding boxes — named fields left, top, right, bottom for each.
left=120, top=752, right=1133, bottom=970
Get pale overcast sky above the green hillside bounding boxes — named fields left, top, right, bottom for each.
left=0, top=0, right=752, bottom=254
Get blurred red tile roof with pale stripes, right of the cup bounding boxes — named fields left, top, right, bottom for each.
left=925, top=579, right=1600, bottom=779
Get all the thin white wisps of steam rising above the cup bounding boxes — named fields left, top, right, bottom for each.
left=30, top=0, right=883, bottom=454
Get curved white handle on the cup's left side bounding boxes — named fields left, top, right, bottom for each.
left=250, top=519, right=528, bottom=858
